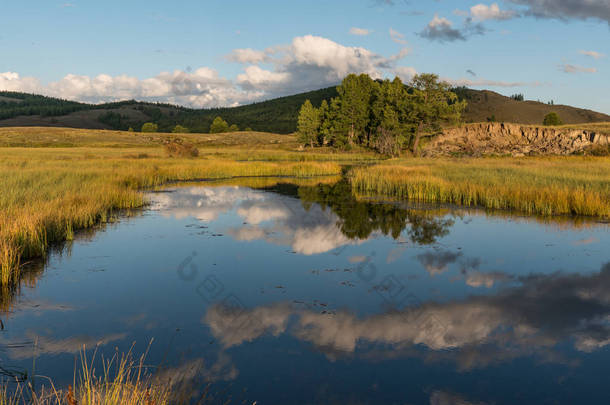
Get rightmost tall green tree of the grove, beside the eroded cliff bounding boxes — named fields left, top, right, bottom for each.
left=410, top=73, right=466, bottom=155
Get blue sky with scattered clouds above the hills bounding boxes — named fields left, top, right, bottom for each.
left=0, top=0, right=610, bottom=114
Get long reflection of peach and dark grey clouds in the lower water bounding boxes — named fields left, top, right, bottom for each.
left=202, top=263, right=610, bottom=369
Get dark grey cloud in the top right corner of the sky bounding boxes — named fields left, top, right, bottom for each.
left=507, top=0, right=610, bottom=24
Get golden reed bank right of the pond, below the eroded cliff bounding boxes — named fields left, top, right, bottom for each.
left=350, top=157, right=610, bottom=218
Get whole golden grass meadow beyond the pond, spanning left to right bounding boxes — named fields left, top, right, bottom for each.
left=0, top=128, right=610, bottom=286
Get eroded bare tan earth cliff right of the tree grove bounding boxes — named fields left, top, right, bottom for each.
left=423, top=123, right=610, bottom=156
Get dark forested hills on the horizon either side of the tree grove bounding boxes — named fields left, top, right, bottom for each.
left=0, top=87, right=610, bottom=134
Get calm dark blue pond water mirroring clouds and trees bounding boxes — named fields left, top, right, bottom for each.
left=0, top=183, right=610, bottom=404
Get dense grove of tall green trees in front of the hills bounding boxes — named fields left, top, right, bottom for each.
left=297, top=74, right=466, bottom=155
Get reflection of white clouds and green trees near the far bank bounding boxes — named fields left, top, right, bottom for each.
left=153, top=181, right=453, bottom=255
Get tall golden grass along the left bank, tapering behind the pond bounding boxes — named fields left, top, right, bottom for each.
left=0, top=148, right=341, bottom=285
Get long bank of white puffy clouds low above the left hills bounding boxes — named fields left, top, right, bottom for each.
left=0, top=35, right=408, bottom=108
